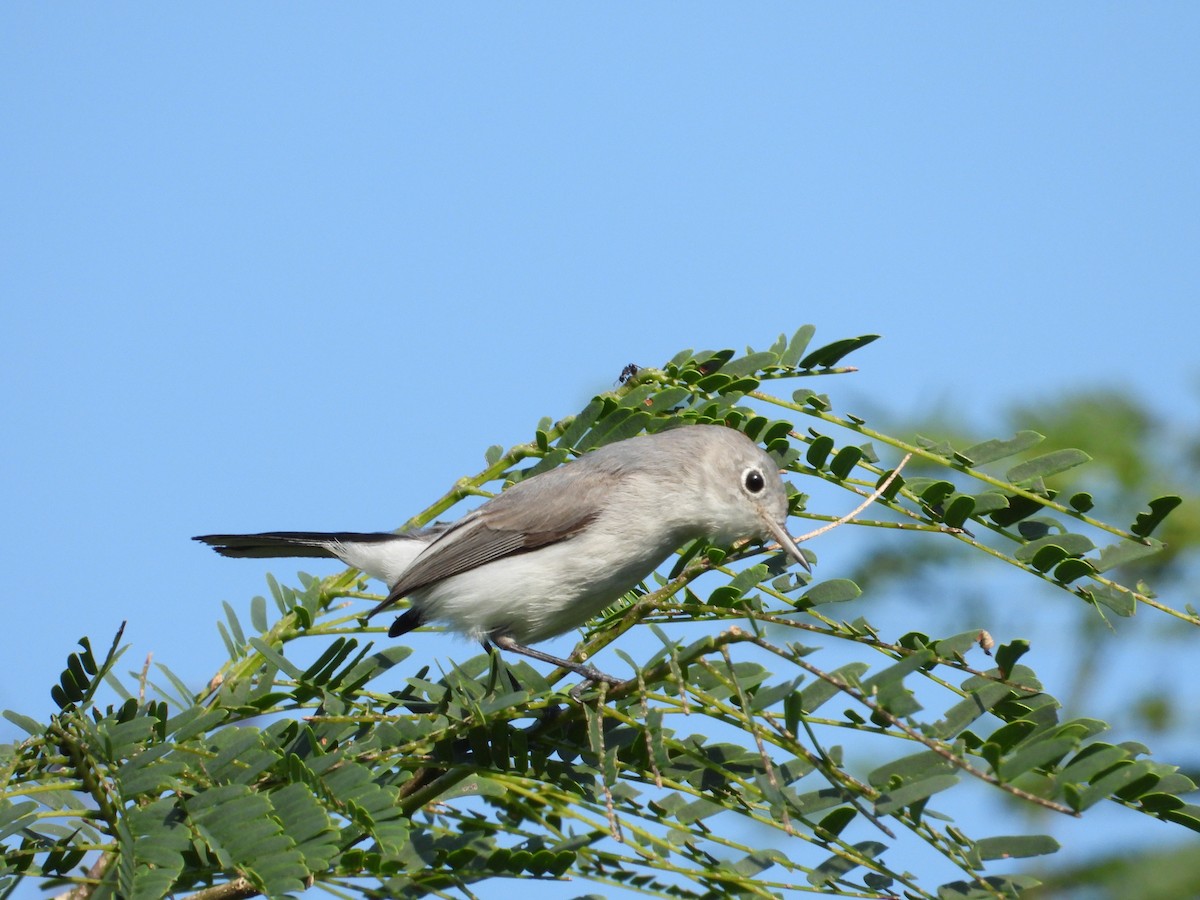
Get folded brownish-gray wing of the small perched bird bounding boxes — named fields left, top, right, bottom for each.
left=371, top=466, right=609, bottom=616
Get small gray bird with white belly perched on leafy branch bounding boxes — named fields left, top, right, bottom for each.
left=194, top=425, right=808, bottom=683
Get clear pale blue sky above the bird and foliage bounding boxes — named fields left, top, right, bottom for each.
left=0, top=2, right=1200, bottom=897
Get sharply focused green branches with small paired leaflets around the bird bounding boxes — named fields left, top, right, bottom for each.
left=0, top=326, right=1200, bottom=898
